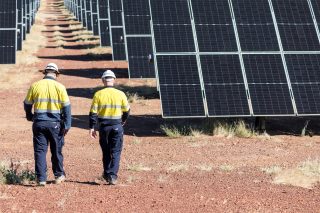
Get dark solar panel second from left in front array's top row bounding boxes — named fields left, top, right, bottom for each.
left=192, top=0, right=237, bottom=52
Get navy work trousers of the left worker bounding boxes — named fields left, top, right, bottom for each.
left=32, top=121, right=65, bottom=182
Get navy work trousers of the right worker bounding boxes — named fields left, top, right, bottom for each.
left=99, top=124, right=123, bottom=180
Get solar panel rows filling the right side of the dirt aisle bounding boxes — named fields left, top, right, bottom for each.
left=63, top=0, right=320, bottom=117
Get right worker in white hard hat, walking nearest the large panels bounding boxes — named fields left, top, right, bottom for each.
left=89, top=70, right=130, bottom=185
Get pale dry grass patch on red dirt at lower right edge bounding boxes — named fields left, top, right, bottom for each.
left=273, top=159, right=320, bottom=189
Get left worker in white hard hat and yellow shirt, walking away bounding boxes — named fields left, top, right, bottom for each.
left=24, top=63, right=71, bottom=186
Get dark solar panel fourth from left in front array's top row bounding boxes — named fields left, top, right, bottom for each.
left=272, top=0, right=320, bottom=51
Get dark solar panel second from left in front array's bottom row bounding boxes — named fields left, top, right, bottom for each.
left=200, top=55, right=250, bottom=116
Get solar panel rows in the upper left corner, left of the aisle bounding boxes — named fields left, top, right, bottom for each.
left=0, top=0, right=40, bottom=64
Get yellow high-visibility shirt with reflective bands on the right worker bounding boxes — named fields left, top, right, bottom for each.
left=90, top=87, right=130, bottom=120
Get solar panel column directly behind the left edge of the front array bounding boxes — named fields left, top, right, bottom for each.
left=123, top=0, right=155, bottom=78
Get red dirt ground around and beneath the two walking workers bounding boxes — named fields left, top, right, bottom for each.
left=0, top=0, right=320, bottom=213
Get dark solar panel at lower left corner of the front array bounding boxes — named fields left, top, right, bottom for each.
left=157, top=55, right=205, bottom=117
